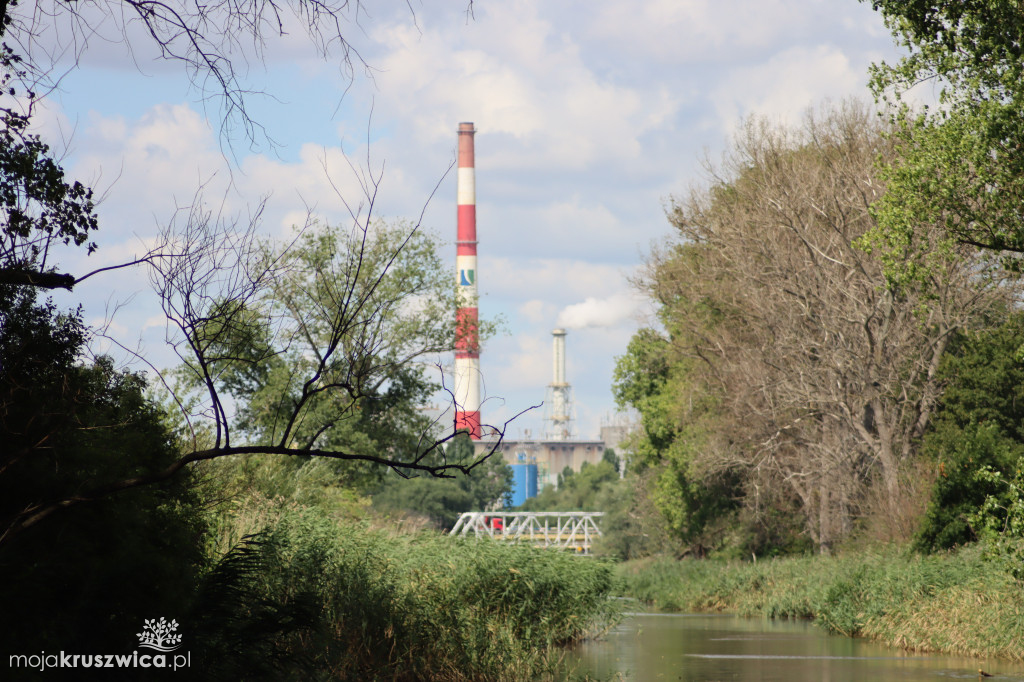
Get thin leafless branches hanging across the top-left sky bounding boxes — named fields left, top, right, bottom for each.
left=7, top=0, right=387, bottom=140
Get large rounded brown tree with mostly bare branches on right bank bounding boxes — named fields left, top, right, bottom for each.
left=615, top=103, right=1024, bottom=554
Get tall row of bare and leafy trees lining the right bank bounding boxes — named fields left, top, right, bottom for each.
left=614, top=1, right=1024, bottom=557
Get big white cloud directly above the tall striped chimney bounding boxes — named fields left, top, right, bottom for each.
left=368, top=0, right=678, bottom=169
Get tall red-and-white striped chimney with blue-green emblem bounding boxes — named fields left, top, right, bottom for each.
left=455, top=123, right=480, bottom=439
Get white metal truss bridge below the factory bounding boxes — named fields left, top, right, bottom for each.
left=449, top=512, right=604, bottom=554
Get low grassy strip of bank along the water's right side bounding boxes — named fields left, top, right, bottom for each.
left=620, top=547, right=1024, bottom=660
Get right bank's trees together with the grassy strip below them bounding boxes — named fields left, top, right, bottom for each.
left=598, top=73, right=1024, bottom=659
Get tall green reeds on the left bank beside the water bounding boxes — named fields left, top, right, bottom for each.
left=192, top=501, right=615, bottom=681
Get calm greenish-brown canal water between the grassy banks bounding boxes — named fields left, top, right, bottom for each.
left=568, top=613, right=1024, bottom=682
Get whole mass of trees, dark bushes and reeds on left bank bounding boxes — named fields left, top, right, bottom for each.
left=0, top=47, right=615, bottom=681
